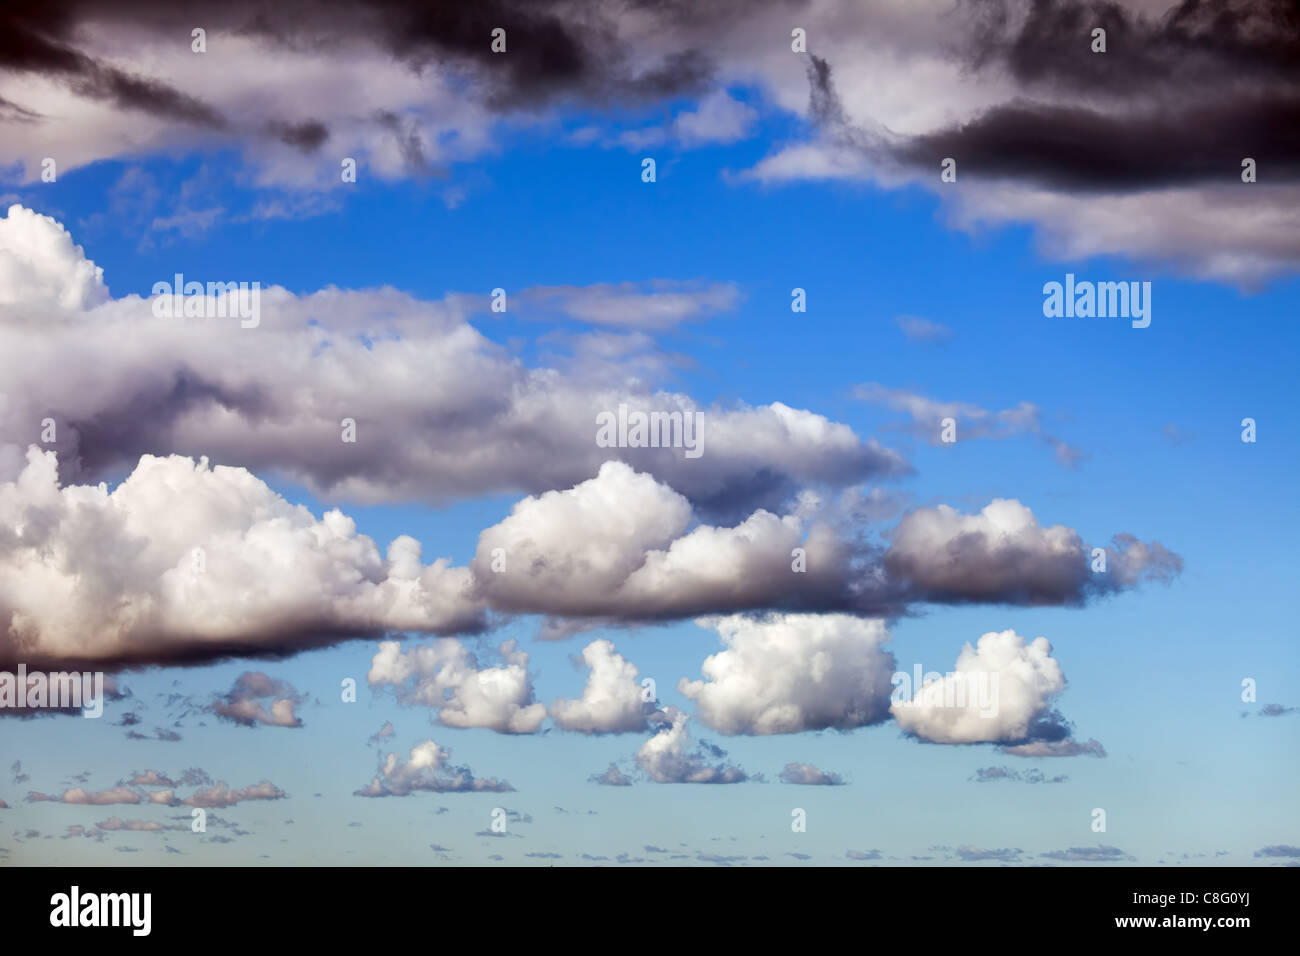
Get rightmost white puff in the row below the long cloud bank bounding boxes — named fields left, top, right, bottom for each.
left=891, top=631, right=1067, bottom=744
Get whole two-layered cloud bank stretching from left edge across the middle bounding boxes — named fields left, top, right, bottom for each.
left=0, top=207, right=1182, bottom=671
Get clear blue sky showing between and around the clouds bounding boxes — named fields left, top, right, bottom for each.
left=0, top=0, right=1300, bottom=865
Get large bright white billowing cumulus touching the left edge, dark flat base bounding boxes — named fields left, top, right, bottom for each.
left=0, top=446, right=480, bottom=665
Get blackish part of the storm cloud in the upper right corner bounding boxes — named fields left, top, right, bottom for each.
left=809, top=0, right=1300, bottom=191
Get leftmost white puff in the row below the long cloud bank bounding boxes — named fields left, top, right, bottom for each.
left=367, top=637, right=546, bottom=734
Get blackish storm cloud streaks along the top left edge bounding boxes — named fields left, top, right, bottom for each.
left=0, top=0, right=712, bottom=119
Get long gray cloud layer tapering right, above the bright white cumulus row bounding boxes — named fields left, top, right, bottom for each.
left=0, top=207, right=909, bottom=516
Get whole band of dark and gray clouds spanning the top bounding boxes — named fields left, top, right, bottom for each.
left=0, top=0, right=1300, bottom=282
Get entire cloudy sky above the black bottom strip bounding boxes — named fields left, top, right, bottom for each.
left=0, top=0, right=1300, bottom=866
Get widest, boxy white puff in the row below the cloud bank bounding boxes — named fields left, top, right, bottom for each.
left=677, top=614, right=896, bottom=735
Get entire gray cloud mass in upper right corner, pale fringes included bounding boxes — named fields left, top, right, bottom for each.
left=750, top=0, right=1300, bottom=287
